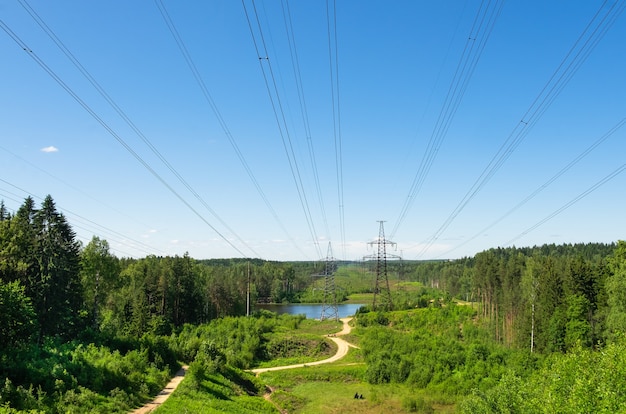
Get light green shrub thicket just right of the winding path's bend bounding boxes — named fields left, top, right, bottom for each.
left=358, top=303, right=514, bottom=395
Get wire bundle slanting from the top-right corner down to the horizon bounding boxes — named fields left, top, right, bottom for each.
left=418, top=0, right=624, bottom=257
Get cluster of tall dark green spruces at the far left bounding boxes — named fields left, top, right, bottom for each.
left=0, top=196, right=84, bottom=340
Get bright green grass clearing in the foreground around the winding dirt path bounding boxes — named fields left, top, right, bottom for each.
left=157, top=314, right=455, bottom=414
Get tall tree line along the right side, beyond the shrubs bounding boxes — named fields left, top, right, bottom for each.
left=404, top=241, right=626, bottom=352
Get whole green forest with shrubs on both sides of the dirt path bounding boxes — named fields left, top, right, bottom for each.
left=0, top=196, right=626, bottom=413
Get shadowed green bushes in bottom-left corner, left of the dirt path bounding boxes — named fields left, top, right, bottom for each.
left=0, top=337, right=176, bottom=413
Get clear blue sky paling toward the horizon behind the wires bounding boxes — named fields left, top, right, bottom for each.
left=0, top=0, right=626, bottom=260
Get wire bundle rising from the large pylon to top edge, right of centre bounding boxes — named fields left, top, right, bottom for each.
left=390, top=0, right=504, bottom=238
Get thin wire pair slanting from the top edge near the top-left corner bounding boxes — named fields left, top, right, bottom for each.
left=18, top=0, right=258, bottom=256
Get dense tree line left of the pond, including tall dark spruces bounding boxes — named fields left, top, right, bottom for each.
left=0, top=196, right=316, bottom=346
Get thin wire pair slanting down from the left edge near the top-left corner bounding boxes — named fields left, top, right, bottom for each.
left=0, top=20, right=252, bottom=257
